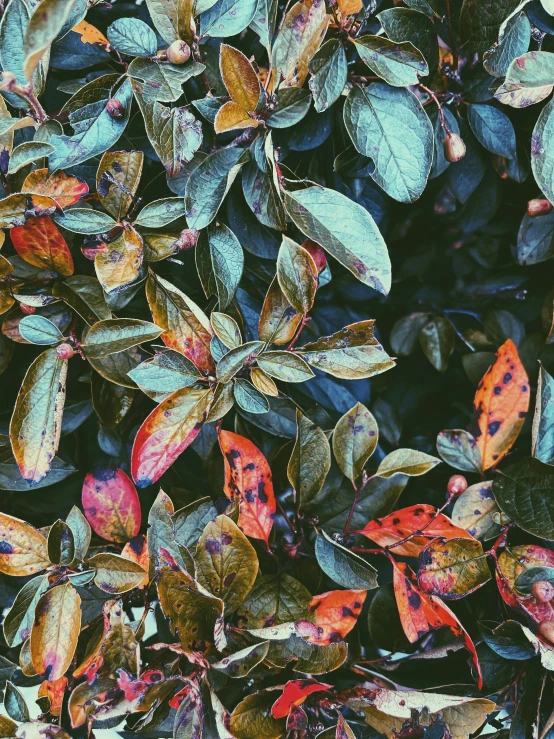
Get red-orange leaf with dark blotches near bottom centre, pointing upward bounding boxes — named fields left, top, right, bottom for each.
left=219, top=431, right=277, bottom=544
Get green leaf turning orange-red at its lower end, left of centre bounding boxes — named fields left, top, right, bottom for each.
left=146, top=271, right=214, bottom=372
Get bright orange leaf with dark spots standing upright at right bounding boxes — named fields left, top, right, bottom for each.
left=472, top=339, right=529, bottom=470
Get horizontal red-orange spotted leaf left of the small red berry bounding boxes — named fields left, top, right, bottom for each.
left=357, top=505, right=473, bottom=557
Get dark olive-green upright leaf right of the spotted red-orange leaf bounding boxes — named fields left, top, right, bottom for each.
left=287, top=409, right=331, bottom=507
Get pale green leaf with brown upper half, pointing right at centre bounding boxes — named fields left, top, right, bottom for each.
left=296, top=321, right=394, bottom=380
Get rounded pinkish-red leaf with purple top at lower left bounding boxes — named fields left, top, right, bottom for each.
left=82, top=467, right=141, bottom=544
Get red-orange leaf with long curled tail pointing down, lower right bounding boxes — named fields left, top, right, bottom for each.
left=391, top=558, right=483, bottom=689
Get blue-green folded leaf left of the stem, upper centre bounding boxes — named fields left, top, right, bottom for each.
left=185, top=146, right=248, bottom=230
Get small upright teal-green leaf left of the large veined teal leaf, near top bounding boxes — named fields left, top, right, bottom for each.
left=309, top=39, right=348, bottom=113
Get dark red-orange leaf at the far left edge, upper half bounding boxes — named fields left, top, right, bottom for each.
left=10, top=217, right=73, bottom=277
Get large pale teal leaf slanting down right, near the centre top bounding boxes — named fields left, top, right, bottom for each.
left=285, top=187, right=391, bottom=295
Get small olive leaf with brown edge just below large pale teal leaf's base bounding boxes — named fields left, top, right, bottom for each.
left=277, top=236, right=319, bottom=315
